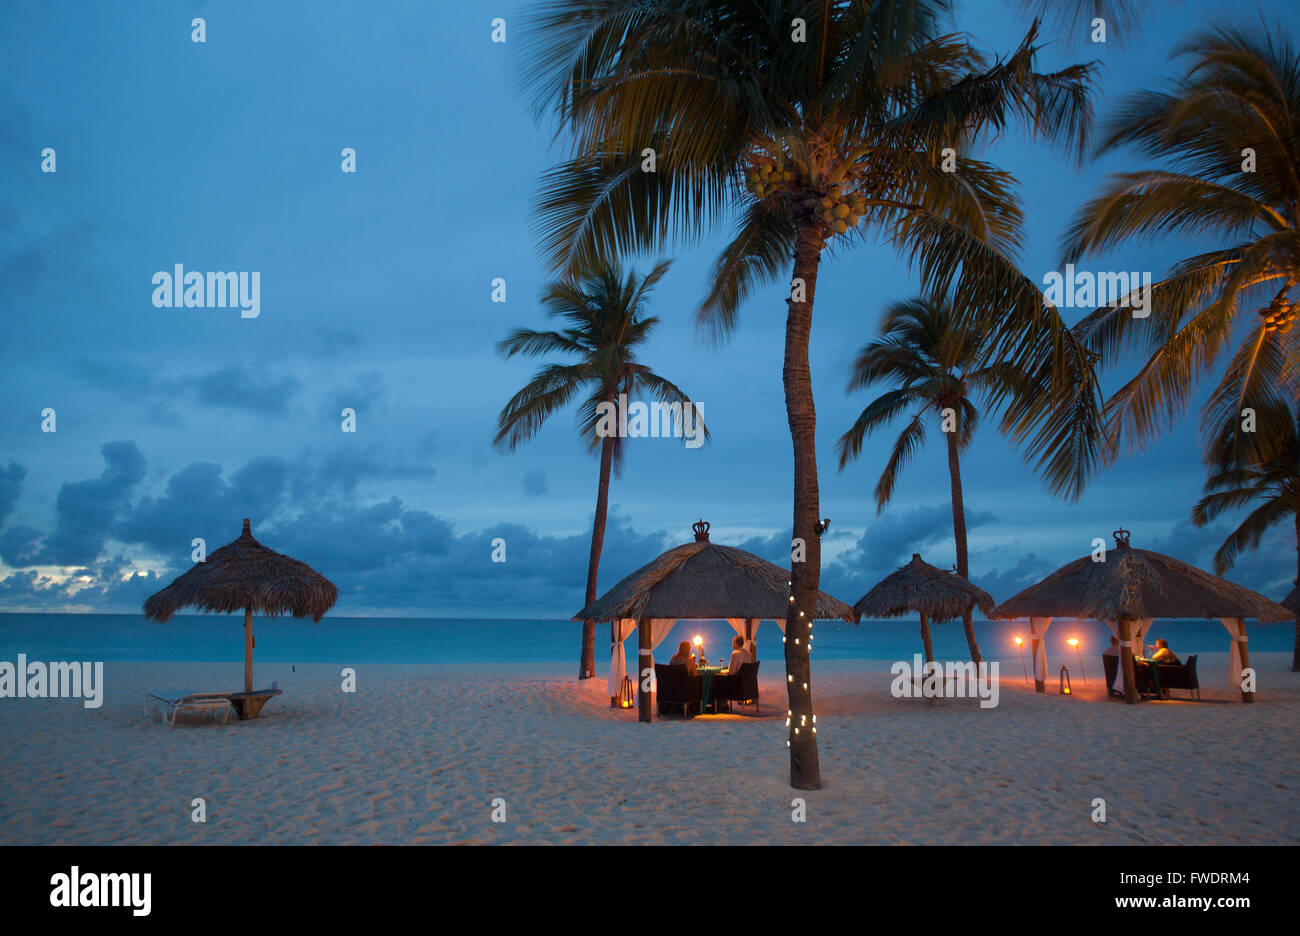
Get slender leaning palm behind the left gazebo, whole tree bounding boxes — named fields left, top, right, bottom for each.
left=494, top=261, right=709, bottom=680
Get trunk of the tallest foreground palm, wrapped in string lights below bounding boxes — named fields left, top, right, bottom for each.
left=781, top=222, right=822, bottom=789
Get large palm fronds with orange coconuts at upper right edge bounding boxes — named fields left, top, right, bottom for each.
left=1065, top=21, right=1300, bottom=475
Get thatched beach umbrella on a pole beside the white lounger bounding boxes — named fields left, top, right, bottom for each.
left=144, top=519, right=338, bottom=707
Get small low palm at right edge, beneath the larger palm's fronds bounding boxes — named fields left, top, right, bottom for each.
left=1192, top=399, right=1300, bottom=672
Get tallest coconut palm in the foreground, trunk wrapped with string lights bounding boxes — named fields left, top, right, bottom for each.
left=527, top=0, right=1095, bottom=789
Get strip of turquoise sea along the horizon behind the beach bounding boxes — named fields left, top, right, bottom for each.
left=0, top=614, right=1294, bottom=668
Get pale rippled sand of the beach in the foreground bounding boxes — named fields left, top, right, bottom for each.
left=0, top=654, right=1300, bottom=845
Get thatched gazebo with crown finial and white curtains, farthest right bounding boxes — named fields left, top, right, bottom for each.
left=992, top=529, right=1294, bottom=702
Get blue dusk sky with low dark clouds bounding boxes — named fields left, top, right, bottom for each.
left=0, top=0, right=1296, bottom=619
